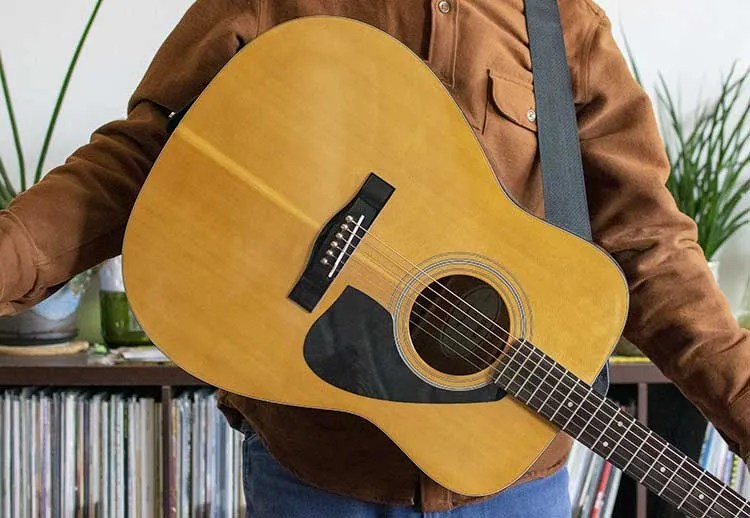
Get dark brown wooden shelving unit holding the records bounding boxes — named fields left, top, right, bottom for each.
left=0, top=353, right=669, bottom=518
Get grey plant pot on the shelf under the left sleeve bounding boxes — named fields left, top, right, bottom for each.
left=0, top=272, right=91, bottom=346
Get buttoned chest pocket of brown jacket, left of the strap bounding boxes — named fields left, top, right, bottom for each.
left=482, top=72, right=541, bottom=211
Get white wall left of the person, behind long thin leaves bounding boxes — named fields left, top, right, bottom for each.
left=0, top=0, right=192, bottom=187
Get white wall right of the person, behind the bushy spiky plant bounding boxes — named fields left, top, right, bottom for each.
left=598, top=0, right=750, bottom=308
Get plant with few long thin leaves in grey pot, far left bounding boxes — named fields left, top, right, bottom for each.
left=0, top=0, right=102, bottom=345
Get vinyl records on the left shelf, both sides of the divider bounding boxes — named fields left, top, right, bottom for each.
left=0, top=388, right=244, bottom=518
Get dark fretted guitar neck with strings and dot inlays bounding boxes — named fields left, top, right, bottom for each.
left=495, top=342, right=750, bottom=518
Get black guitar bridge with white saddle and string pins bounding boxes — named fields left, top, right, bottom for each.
left=289, top=173, right=395, bottom=312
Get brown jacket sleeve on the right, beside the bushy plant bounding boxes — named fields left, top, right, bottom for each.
left=578, top=17, right=750, bottom=458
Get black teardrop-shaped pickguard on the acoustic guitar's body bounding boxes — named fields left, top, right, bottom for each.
left=304, top=287, right=505, bottom=403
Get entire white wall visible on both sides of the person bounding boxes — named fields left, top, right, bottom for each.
left=0, top=0, right=750, bottom=305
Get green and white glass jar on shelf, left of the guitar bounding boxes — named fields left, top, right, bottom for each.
left=99, top=255, right=151, bottom=347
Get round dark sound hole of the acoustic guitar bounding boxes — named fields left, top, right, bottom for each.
left=409, top=275, right=510, bottom=375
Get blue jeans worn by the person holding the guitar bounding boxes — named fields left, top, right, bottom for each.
left=242, top=425, right=571, bottom=518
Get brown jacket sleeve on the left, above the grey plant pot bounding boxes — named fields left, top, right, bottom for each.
left=0, top=0, right=258, bottom=315
